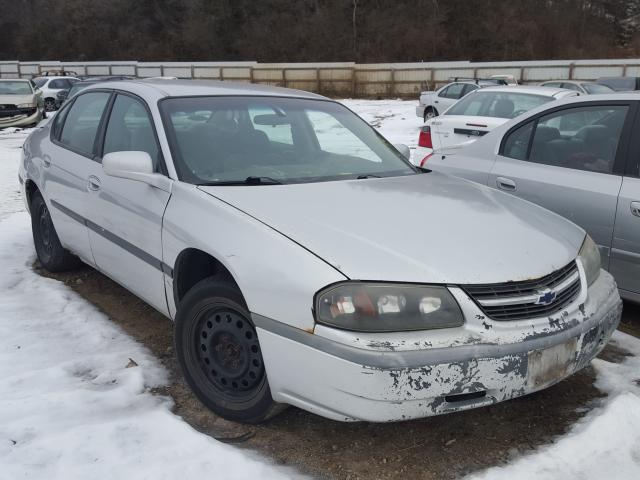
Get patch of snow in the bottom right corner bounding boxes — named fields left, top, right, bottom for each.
left=468, top=332, right=640, bottom=480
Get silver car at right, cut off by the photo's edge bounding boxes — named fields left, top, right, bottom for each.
left=425, top=93, right=640, bottom=302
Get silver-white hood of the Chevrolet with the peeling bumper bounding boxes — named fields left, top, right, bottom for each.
left=199, top=172, right=585, bottom=284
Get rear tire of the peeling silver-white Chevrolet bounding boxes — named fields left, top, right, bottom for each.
left=30, top=192, right=80, bottom=272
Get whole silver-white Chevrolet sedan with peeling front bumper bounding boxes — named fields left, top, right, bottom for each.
left=20, top=80, right=621, bottom=422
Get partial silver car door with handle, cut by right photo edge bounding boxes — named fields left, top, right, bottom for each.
left=610, top=106, right=640, bottom=301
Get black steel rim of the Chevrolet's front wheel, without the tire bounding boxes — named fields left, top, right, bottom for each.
left=193, top=307, right=265, bottom=396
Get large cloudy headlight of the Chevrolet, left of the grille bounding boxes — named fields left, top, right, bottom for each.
left=315, top=282, right=463, bottom=332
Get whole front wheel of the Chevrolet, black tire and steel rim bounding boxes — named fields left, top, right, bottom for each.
left=174, top=277, right=285, bottom=423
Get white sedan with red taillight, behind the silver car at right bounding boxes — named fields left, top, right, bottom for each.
left=413, top=86, right=579, bottom=166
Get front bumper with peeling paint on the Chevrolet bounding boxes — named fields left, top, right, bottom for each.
left=254, top=271, right=622, bottom=422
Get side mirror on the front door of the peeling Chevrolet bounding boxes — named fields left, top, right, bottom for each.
left=102, top=151, right=173, bottom=192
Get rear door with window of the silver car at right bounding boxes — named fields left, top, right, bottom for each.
left=488, top=102, right=635, bottom=269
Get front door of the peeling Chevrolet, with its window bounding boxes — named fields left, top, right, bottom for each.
left=88, top=93, right=170, bottom=314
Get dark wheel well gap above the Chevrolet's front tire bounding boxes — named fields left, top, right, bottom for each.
left=173, top=248, right=240, bottom=306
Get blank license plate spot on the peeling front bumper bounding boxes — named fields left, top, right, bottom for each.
left=527, top=338, right=577, bottom=389
